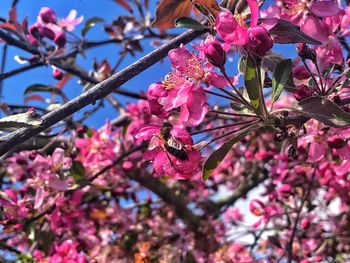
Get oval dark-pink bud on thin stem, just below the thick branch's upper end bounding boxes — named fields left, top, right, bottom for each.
left=204, top=37, right=226, bottom=68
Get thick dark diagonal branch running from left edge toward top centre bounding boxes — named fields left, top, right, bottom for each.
left=0, top=27, right=206, bottom=155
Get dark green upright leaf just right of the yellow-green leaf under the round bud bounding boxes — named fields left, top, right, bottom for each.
left=272, top=59, right=293, bottom=102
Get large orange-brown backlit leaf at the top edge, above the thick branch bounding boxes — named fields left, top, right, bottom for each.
left=152, top=0, right=192, bottom=30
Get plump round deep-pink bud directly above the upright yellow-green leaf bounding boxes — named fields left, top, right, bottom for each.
left=246, top=26, right=273, bottom=57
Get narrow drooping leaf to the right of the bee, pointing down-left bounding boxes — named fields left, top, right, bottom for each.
left=202, top=124, right=260, bottom=180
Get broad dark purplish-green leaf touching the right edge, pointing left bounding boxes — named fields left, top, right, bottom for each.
left=297, top=97, right=350, bottom=128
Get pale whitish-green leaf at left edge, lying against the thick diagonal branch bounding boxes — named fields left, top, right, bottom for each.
left=0, top=111, right=42, bottom=131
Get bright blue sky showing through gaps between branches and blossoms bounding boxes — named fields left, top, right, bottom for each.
left=0, top=0, right=294, bottom=128
